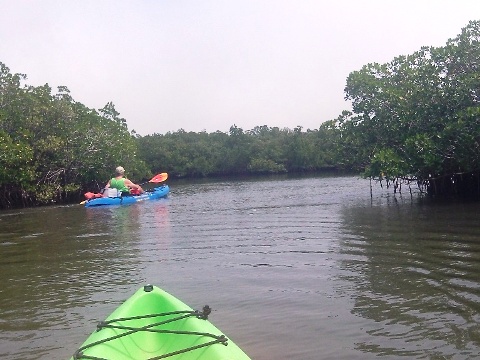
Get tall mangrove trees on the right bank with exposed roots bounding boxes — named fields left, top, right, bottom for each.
left=341, top=21, right=480, bottom=193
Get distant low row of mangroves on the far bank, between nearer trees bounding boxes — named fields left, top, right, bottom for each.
left=137, top=125, right=335, bottom=177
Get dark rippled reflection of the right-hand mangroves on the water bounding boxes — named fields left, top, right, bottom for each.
left=341, top=202, right=480, bottom=358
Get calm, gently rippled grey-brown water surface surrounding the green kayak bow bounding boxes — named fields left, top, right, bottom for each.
left=0, top=177, right=480, bottom=360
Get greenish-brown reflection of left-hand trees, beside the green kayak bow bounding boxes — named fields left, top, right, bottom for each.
left=0, top=204, right=171, bottom=359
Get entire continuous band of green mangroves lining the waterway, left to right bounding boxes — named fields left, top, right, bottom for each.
left=0, top=21, right=480, bottom=208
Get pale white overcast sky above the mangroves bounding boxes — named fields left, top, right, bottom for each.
left=0, top=0, right=480, bottom=135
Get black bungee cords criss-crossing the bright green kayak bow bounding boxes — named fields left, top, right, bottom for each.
left=73, top=305, right=228, bottom=360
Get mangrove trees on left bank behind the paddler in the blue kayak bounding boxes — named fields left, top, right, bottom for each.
left=0, top=63, right=150, bottom=207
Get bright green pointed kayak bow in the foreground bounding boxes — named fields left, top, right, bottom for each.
left=71, top=285, right=250, bottom=360
